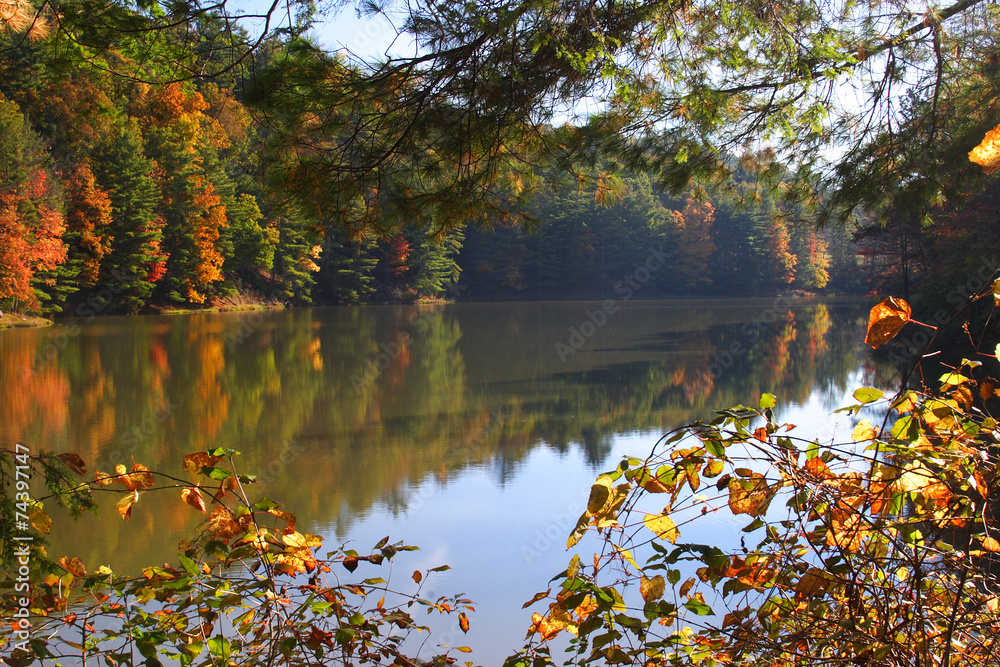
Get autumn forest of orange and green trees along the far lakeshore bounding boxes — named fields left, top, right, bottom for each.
left=0, top=0, right=995, bottom=317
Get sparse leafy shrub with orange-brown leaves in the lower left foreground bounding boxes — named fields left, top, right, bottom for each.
left=0, top=449, right=472, bottom=667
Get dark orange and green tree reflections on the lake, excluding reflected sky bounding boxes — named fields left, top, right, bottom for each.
left=0, top=300, right=866, bottom=571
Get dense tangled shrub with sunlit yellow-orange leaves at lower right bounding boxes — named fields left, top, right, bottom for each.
left=506, top=296, right=1000, bottom=667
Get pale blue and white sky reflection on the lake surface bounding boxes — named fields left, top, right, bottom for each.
left=336, top=371, right=892, bottom=665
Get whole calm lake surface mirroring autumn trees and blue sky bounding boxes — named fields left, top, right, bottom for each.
left=0, top=299, right=886, bottom=665
